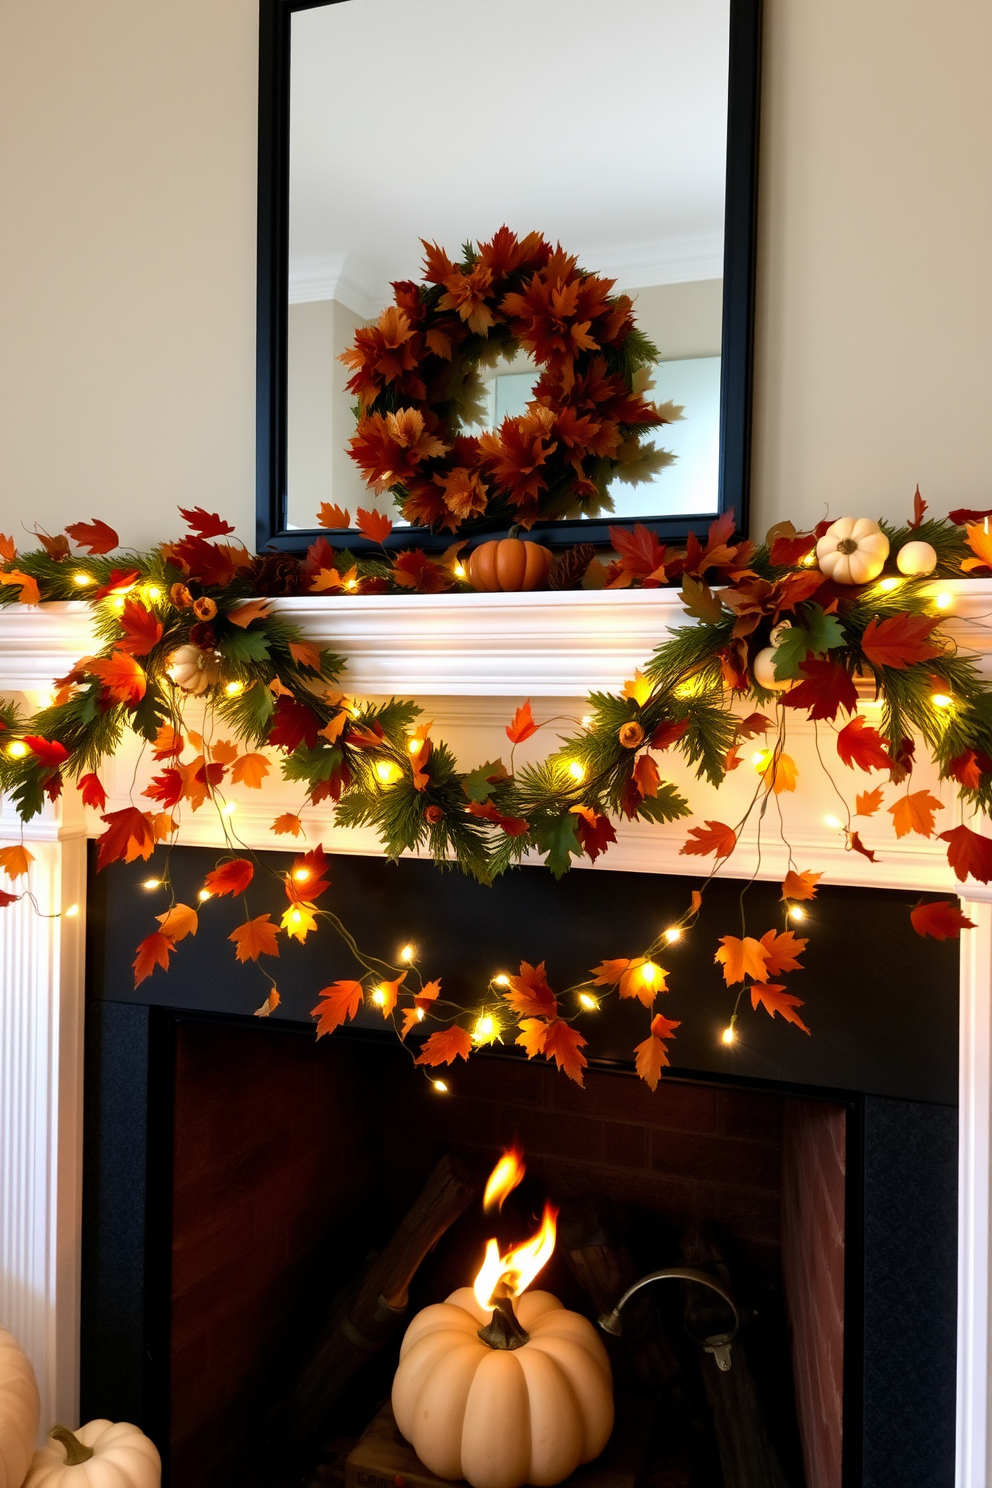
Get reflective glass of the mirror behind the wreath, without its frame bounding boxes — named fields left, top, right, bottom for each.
left=287, top=0, right=730, bottom=528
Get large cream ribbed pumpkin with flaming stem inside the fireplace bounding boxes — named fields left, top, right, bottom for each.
left=393, top=1287, right=613, bottom=1488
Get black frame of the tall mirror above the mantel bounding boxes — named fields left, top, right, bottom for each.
left=256, top=0, right=761, bottom=552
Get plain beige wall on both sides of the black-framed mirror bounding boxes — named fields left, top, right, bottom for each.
left=0, top=0, right=992, bottom=542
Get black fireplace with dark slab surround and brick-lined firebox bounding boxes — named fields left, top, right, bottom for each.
left=82, top=848, right=956, bottom=1488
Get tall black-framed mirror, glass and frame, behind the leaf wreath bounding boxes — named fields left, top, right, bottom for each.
left=257, top=0, right=760, bottom=552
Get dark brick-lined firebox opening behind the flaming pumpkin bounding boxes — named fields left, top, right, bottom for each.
left=168, top=1018, right=846, bottom=1488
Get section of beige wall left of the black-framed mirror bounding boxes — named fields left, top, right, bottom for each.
left=0, top=0, right=257, bottom=545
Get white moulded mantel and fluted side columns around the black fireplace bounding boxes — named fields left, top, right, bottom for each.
left=0, top=582, right=992, bottom=1488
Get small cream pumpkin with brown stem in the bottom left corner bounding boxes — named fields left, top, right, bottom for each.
left=24, top=1421, right=162, bottom=1488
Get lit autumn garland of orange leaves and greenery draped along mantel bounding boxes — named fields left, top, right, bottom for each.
left=0, top=496, right=992, bottom=1085
